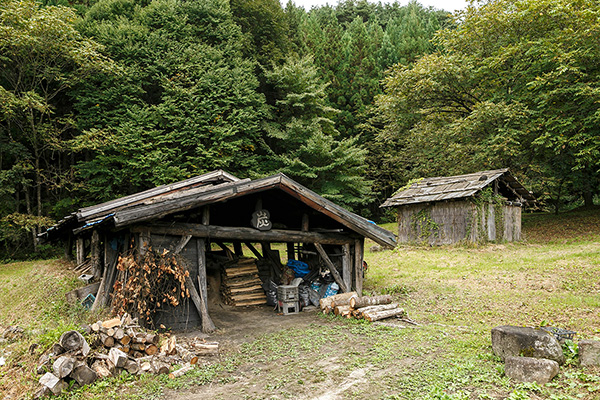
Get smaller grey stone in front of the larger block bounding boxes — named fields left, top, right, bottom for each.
left=504, top=357, right=559, bottom=385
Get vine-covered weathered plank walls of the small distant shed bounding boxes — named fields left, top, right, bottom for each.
left=398, top=201, right=521, bottom=245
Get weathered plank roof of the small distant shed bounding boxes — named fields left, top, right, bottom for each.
left=381, top=168, right=535, bottom=207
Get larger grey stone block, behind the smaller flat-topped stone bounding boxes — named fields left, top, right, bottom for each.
left=492, top=325, right=565, bottom=364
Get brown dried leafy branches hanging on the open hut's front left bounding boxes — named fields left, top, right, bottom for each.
left=112, top=249, right=190, bottom=326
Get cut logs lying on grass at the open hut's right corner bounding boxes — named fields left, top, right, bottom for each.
left=319, top=292, right=406, bottom=322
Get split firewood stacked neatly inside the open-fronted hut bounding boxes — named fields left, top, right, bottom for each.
left=221, top=258, right=267, bottom=307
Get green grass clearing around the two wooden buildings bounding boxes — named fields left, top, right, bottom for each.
left=0, top=210, right=600, bottom=400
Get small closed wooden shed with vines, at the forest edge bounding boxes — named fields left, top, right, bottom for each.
left=381, top=168, right=535, bottom=245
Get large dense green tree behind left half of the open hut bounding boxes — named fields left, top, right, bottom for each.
left=73, top=0, right=265, bottom=201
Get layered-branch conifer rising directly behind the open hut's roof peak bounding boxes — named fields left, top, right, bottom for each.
left=266, top=57, right=370, bottom=207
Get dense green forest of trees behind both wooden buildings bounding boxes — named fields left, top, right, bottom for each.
left=0, top=0, right=600, bottom=259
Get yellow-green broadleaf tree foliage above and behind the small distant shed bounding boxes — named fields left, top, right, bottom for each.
left=376, top=0, right=600, bottom=210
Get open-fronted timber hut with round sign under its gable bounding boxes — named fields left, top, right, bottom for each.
left=39, top=170, right=396, bottom=330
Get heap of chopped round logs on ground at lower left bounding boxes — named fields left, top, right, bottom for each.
left=35, top=314, right=219, bottom=398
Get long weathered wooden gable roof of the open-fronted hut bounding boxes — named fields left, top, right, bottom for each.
left=40, top=170, right=396, bottom=247
